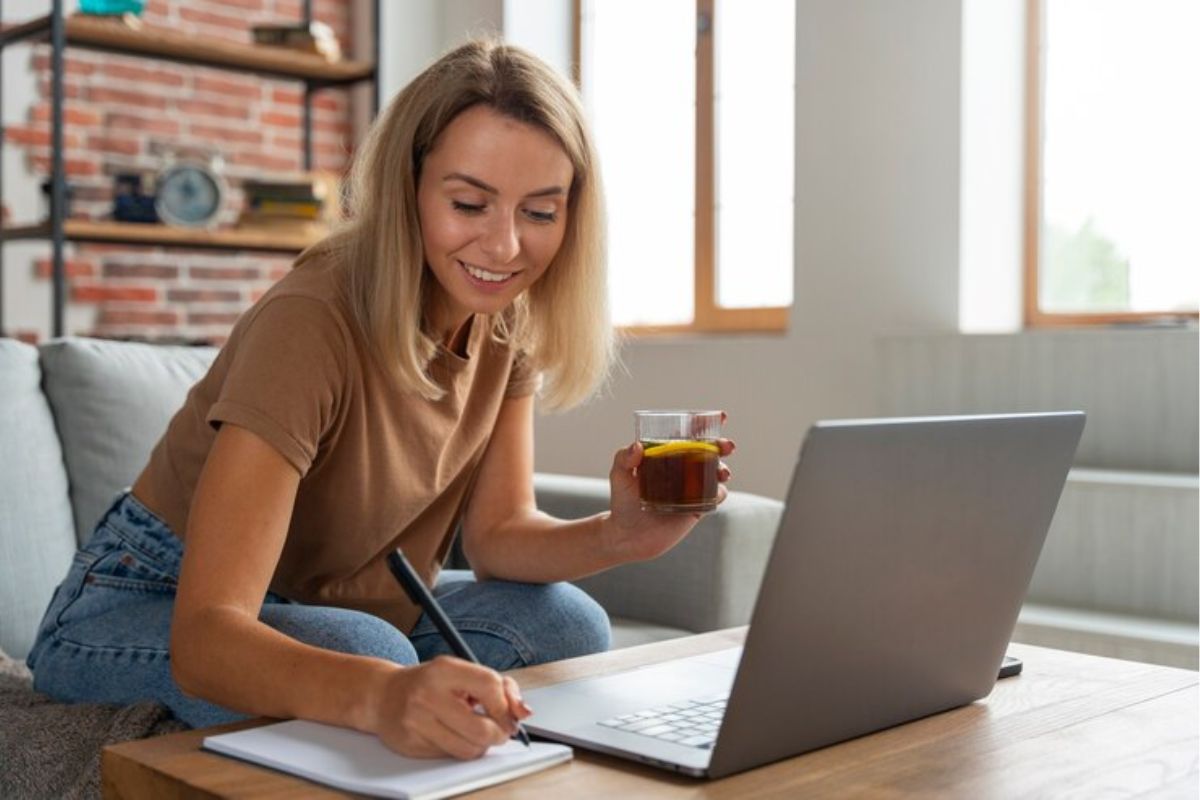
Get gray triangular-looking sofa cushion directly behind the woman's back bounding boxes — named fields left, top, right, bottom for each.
left=41, top=338, right=217, bottom=543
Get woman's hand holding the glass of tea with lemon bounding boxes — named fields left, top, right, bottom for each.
left=607, top=431, right=737, bottom=561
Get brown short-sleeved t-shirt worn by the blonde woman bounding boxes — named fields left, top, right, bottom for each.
left=137, top=259, right=538, bottom=632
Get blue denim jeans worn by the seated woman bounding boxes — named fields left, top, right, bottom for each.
left=28, top=493, right=610, bottom=727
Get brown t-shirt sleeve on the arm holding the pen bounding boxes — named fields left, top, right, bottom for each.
left=206, top=295, right=349, bottom=476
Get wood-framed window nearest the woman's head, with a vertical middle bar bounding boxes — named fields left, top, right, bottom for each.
left=578, top=0, right=796, bottom=332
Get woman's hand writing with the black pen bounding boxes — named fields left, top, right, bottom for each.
left=373, top=656, right=533, bottom=759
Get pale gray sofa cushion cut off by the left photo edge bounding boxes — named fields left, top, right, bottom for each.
left=0, top=339, right=76, bottom=658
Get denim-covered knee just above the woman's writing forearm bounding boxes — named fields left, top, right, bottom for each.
left=260, top=603, right=418, bottom=664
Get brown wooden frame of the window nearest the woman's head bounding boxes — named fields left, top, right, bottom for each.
left=572, top=0, right=796, bottom=336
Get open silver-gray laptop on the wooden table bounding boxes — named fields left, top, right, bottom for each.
left=524, top=411, right=1084, bottom=777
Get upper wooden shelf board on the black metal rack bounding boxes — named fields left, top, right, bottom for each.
left=2, top=14, right=376, bottom=85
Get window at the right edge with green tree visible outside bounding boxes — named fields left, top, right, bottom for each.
left=1025, top=0, right=1200, bottom=325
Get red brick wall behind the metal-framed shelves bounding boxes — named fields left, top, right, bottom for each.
left=5, top=0, right=353, bottom=343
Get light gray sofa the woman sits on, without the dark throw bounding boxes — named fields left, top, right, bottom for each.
left=0, top=338, right=782, bottom=660
